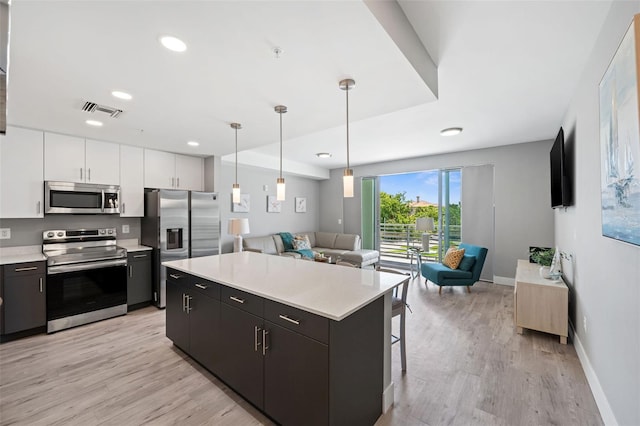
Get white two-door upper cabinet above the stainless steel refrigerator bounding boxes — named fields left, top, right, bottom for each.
left=144, top=149, right=204, bottom=191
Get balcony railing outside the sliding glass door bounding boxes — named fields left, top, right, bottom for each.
left=380, top=223, right=460, bottom=264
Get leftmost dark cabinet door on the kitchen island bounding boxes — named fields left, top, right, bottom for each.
left=165, top=280, right=189, bottom=352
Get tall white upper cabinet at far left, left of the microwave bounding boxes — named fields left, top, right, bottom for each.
left=0, top=126, right=44, bottom=219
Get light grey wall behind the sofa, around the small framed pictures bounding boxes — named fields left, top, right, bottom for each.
left=215, top=162, right=320, bottom=253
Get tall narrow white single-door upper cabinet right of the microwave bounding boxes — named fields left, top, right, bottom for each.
left=120, top=145, right=144, bottom=217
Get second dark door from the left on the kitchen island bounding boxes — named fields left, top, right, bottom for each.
left=188, top=291, right=222, bottom=371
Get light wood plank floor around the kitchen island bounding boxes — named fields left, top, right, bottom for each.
left=0, top=279, right=602, bottom=425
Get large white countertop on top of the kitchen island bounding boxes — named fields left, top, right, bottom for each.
left=162, top=251, right=407, bottom=321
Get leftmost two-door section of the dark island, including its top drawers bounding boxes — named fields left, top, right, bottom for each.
left=165, top=271, right=220, bottom=371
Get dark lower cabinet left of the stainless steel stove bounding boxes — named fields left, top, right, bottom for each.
left=0, top=262, right=47, bottom=334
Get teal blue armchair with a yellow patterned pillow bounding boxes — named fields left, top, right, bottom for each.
left=420, top=243, right=488, bottom=294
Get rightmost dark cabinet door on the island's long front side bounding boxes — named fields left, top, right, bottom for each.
left=264, top=321, right=329, bottom=425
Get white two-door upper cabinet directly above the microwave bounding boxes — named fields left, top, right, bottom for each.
left=44, top=133, right=120, bottom=185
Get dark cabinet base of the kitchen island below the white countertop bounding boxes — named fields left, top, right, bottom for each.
left=166, top=268, right=384, bottom=425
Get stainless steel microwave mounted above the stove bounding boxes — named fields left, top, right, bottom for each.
left=44, top=181, right=120, bottom=214
